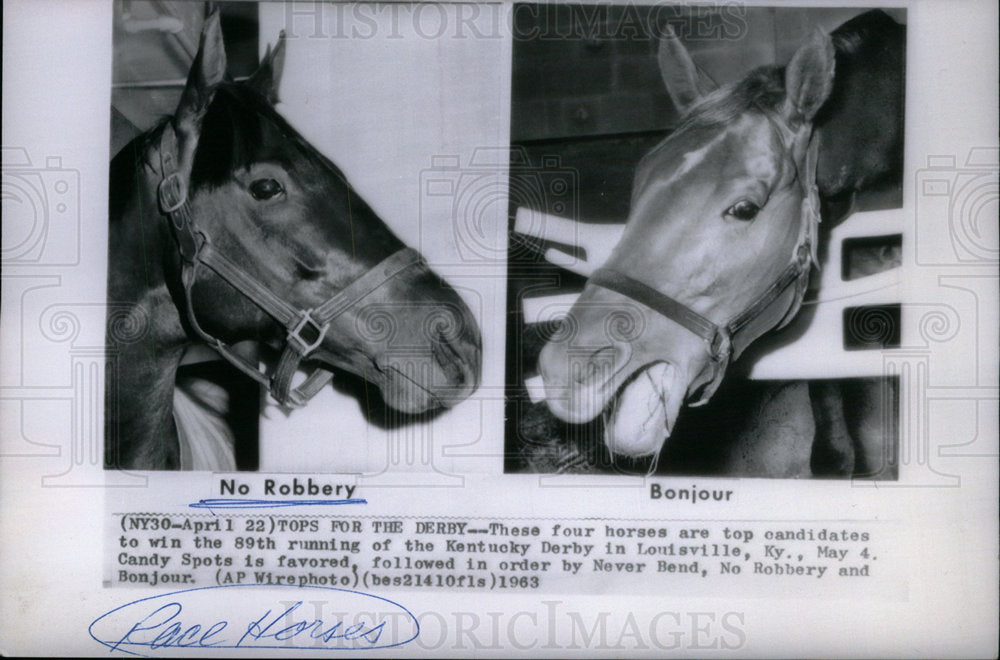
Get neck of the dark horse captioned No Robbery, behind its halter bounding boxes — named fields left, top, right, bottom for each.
left=105, top=130, right=188, bottom=469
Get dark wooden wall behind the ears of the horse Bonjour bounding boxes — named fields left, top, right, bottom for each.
left=511, top=4, right=905, bottom=142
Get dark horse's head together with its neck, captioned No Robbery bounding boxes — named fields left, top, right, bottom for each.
left=106, top=13, right=481, bottom=469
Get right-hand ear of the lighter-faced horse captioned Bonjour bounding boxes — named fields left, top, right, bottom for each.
left=782, top=29, right=836, bottom=127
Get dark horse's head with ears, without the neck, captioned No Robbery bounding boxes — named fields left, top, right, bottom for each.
left=157, top=13, right=481, bottom=413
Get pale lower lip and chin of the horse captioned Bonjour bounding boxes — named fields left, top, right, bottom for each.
left=604, top=362, right=687, bottom=458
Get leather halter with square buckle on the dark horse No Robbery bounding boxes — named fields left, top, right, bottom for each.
left=157, top=122, right=422, bottom=407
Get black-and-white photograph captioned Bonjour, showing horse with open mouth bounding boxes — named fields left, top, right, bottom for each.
left=506, top=5, right=906, bottom=480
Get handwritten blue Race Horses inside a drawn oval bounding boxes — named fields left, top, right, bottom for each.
left=88, top=584, right=420, bottom=656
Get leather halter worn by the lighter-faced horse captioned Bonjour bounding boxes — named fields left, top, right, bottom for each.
left=588, top=132, right=820, bottom=406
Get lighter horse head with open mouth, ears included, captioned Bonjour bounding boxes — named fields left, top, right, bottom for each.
left=539, top=28, right=834, bottom=457
